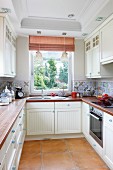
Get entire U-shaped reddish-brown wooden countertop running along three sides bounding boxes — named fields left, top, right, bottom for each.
left=0, top=97, right=113, bottom=148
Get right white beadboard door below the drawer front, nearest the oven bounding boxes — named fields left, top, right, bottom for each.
left=55, top=108, right=81, bottom=134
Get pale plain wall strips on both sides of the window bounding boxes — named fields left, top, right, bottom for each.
left=15, top=37, right=85, bottom=93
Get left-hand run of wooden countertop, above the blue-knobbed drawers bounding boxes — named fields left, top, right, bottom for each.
left=0, top=99, right=26, bottom=149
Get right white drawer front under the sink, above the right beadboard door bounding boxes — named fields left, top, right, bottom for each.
left=55, top=102, right=81, bottom=109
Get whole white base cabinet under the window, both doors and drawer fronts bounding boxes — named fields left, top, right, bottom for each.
left=27, top=102, right=81, bottom=135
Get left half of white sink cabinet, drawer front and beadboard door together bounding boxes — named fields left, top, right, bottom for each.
left=27, top=102, right=54, bottom=135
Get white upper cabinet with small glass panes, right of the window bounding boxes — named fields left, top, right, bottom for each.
left=85, top=32, right=100, bottom=78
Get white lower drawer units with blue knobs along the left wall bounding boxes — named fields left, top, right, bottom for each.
left=0, top=109, right=26, bottom=170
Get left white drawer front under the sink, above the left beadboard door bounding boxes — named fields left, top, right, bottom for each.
left=27, top=102, right=54, bottom=109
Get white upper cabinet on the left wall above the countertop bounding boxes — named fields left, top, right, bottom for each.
left=0, top=15, right=16, bottom=77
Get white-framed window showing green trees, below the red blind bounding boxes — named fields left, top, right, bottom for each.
left=29, top=50, right=74, bottom=94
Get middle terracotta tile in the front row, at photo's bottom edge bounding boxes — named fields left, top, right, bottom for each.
left=43, top=153, right=76, bottom=170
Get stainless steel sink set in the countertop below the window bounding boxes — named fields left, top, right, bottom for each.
left=27, top=96, right=66, bottom=100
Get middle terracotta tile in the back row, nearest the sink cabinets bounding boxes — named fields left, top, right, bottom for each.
left=41, top=140, right=67, bottom=153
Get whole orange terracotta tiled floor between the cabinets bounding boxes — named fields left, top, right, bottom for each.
left=19, top=138, right=109, bottom=170
